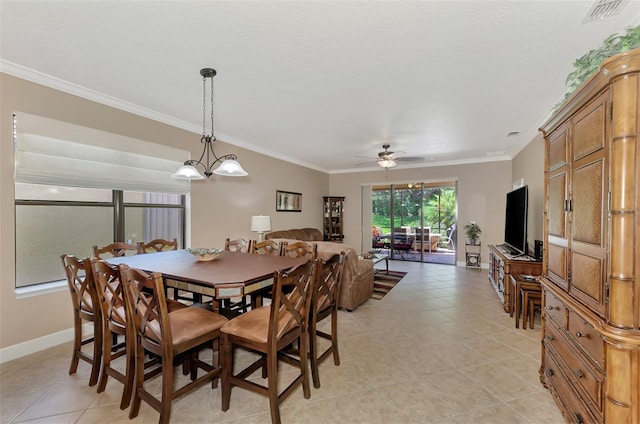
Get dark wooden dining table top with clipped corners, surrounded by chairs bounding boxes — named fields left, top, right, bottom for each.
left=108, top=250, right=306, bottom=299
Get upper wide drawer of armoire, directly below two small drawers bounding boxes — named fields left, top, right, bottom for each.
left=544, top=324, right=604, bottom=412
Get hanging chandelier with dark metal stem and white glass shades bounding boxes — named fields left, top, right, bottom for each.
left=173, top=68, right=249, bottom=180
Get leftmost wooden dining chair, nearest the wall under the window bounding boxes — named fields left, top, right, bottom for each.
left=61, top=254, right=103, bottom=386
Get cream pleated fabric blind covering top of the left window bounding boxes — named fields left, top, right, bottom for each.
left=14, top=113, right=190, bottom=194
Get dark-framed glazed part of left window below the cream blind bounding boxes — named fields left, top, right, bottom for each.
left=15, top=183, right=185, bottom=288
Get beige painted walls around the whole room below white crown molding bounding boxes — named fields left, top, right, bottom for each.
left=0, top=73, right=543, bottom=348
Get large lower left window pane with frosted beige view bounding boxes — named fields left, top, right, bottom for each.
left=16, top=205, right=113, bottom=287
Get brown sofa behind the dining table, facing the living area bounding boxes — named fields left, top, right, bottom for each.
left=265, top=228, right=373, bottom=311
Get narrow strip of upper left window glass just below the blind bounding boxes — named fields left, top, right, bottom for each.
left=15, top=183, right=113, bottom=202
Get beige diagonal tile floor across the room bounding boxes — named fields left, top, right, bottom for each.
left=0, top=261, right=564, bottom=424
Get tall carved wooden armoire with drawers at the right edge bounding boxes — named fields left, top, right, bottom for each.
left=540, top=49, right=640, bottom=424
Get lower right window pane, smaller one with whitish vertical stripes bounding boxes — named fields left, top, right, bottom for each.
left=124, top=206, right=184, bottom=248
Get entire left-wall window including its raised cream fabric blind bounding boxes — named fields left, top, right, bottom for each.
left=13, top=113, right=190, bottom=288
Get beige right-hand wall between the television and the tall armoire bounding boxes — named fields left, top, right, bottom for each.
left=511, top=134, right=544, bottom=255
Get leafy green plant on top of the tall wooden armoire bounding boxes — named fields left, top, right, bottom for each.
left=555, top=25, right=640, bottom=109
